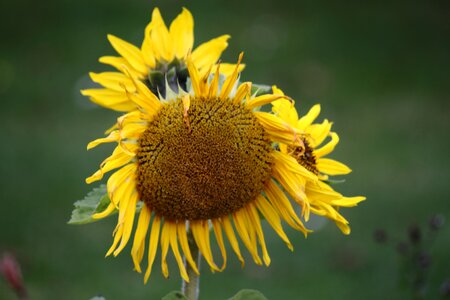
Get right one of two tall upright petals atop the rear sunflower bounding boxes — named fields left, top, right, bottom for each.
left=170, top=8, right=194, bottom=59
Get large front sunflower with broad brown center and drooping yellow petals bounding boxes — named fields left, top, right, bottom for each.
left=86, top=55, right=324, bottom=282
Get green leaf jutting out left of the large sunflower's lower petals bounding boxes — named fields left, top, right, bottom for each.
left=67, top=184, right=115, bottom=224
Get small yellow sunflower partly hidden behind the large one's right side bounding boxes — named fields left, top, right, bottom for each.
left=272, top=87, right=366, bottom=234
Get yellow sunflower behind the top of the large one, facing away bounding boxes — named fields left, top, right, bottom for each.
left=82, top=8, right=243, bottom=112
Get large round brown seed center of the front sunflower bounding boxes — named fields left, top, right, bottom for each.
left=137, top=98, right=272, bottom=220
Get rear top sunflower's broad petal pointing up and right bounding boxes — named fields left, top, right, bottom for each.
left=192, top=35, right=230, bottom=69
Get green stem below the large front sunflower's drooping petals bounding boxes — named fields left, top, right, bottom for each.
left=181, top=230, right=201, bottom=300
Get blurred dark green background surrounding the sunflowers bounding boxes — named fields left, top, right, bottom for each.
left=0, top=0, right=450, bottom=300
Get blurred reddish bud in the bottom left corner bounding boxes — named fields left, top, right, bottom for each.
left=0, top=253, right=26, bottom=297
